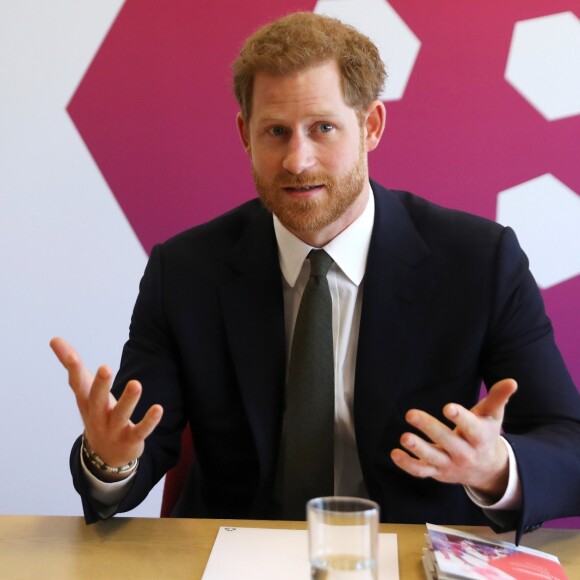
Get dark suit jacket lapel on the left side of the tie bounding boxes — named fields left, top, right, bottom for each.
left=220, top=210, right=286, bottom=476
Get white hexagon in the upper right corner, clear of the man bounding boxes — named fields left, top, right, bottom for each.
left=505, top=12, right=580, bottom=121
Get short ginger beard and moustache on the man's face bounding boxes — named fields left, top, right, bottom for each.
left=252, top=131, right=368, bottom=233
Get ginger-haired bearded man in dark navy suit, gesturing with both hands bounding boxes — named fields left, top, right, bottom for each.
left=51, top=13, right=580, bottom=538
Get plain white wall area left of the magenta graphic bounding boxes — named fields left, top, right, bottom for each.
left=0, top=0, right=161, bottom=516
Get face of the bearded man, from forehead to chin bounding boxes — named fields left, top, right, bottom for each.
left=238, top=63, right=368, bottom=245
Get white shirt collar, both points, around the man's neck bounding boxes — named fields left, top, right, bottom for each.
left=274, top=190, right=375, bottom=287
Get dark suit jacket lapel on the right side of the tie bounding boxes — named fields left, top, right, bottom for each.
left=354, top=183, right=434, bottom=476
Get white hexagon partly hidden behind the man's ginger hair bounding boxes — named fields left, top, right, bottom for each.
left=314, top=0, right=421, bottom=101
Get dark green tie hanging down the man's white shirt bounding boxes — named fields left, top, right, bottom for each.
left=276, top=250, right=334, bottom=520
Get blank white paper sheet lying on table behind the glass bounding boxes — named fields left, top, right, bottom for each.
left=203, top=527, right=398, bottom=580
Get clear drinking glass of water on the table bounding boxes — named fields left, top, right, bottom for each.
left=306, top=497, right=379, bottom=580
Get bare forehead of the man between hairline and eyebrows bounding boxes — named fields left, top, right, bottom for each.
left=252, top=62, right=353, bottom=119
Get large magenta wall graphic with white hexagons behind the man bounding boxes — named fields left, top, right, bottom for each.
left=68, top=0, right=580, bottom=524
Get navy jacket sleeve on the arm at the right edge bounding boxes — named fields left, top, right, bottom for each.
left=482, top=228, right=580, bottom=540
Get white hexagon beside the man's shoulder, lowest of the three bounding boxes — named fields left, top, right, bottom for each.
left=497, top=173, right=580, bottom=289
